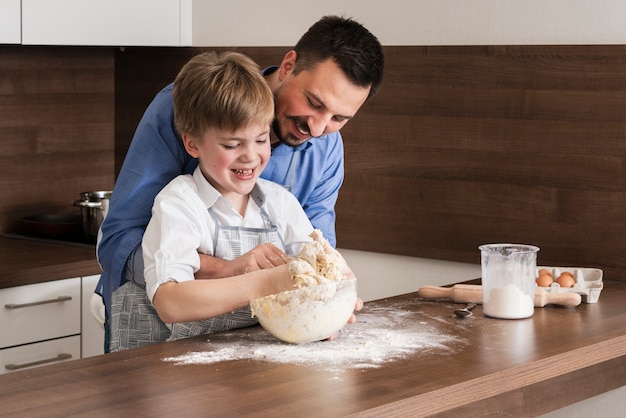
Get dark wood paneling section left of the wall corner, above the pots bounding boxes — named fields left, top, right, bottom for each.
left=0, top=45, right=114, bottom=232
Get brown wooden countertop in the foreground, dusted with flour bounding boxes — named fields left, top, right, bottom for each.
left=0, top=282, right=626, bottom=417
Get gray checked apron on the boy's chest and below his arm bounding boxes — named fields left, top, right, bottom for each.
left=110, top=201, right=285, bottom=352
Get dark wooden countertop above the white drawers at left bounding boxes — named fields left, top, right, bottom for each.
left=0, top=236, right=101, bottom=289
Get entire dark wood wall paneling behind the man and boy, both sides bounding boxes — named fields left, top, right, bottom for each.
left=8, top=45, right=626, bottom=280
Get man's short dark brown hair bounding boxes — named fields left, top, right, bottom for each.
left=294, top=16, right=384, bottom=99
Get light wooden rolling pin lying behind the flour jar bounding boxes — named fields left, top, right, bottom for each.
left=417, top=284, right=582, bottom=308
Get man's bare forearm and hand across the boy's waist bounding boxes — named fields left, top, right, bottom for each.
left=195, top=243, right=290, bottom=279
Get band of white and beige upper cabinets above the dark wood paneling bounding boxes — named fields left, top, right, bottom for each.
left=6, top=0, right=626, bottom=47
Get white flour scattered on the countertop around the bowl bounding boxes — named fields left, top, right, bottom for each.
left=163, top=308, right=460, bottom=371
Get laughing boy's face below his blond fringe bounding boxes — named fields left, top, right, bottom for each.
left=183, top=123, right=271, bottom=199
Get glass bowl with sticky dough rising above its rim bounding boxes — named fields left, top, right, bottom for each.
left=250, top=230, right=357, bottom=344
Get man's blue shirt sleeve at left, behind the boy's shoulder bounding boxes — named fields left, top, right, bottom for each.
left=97, top=85, right=191, bottom=292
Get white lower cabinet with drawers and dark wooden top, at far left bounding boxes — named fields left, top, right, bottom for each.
left=0, top=236, right=104, bottom=374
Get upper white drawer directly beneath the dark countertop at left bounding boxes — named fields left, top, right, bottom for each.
left=0, top=277, right=81, bottom=348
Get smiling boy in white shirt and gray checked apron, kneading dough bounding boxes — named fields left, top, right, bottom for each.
left=111, top=52, right=313, bottom=351
